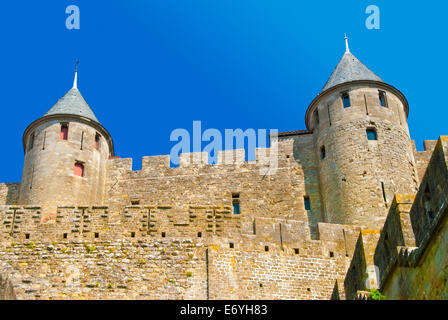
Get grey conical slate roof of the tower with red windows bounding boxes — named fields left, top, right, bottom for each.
left=45, top=86, right=99, bottom=123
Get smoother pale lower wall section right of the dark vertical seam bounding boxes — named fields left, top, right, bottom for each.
left=209, top=241, right=349, bottom=300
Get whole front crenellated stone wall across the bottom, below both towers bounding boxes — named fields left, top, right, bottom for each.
left=0, top=205, right=359, bottom=299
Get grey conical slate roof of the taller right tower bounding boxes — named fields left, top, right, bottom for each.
left=322, top=50, right=384, bottom=92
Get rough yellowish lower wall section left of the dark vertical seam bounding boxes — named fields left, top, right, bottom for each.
left=0, top=239, right=206, bottom=300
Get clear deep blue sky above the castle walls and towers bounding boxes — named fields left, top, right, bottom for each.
left=0, top=0, right=448, bottom=182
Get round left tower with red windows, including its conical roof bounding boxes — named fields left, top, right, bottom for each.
left=19, top=71, right=114, bottom=206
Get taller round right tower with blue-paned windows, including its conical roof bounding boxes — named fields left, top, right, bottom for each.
left=305, top=38, right=419, bottom=228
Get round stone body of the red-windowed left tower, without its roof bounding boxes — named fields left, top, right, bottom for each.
left=18, top=120, right=110, bottom=206
